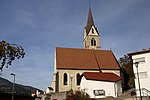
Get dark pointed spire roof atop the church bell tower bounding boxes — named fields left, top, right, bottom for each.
left=85, top=6, right=98, bottom=34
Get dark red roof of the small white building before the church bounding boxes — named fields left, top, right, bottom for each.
left=83, top=72, right=121, bottom=82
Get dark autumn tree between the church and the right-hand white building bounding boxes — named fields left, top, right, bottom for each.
left=119, top=55, right=135, bottom=90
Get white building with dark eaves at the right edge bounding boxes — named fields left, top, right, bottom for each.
left=128, top=49, right=150, bottom=96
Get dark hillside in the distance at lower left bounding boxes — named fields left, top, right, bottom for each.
left=0, top=77, right=43, bottom=96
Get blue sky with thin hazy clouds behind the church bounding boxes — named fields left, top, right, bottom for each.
left=0, top=0, right=150, bottom=90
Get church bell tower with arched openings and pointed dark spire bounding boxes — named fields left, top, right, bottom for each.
left=83, top=6, right=101, bottom=49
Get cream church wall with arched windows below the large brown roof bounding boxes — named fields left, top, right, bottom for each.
left=53, top=69, right=120, bottom=92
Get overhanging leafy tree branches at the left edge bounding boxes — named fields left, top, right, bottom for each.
left=0, top=40, right=25, bottom=71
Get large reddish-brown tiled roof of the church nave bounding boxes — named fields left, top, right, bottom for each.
left=56, top=48, right=120, bottom=70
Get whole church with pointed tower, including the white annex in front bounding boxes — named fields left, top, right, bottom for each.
left=52, top=6, right=122, bottom=98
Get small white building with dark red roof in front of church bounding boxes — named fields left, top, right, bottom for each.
left=80, top=72, right=122, bottom=98
